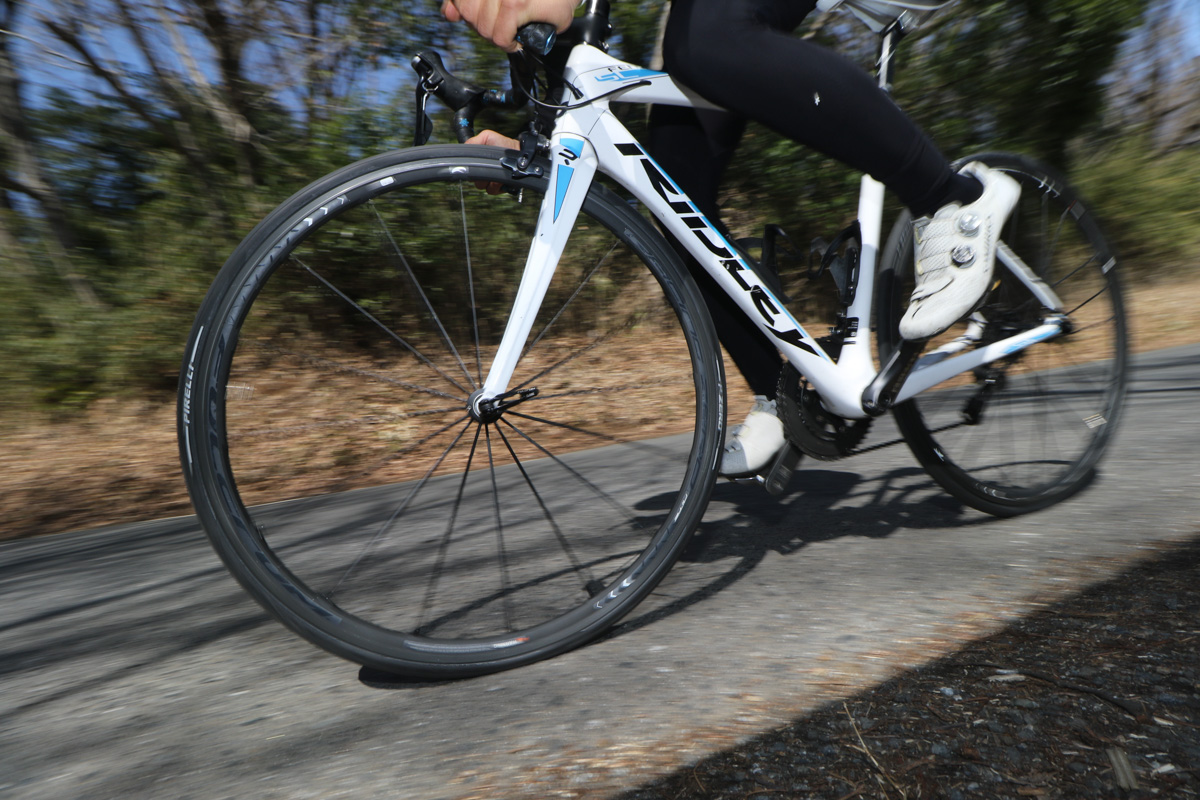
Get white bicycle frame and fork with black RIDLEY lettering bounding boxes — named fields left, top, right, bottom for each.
left=475, top=44, right=1066, bottom=419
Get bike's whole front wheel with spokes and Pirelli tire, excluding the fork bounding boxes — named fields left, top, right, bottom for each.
left=179, top=146, right=725, bottom=679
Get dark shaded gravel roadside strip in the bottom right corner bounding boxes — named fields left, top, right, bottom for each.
left=620, top=539, right=1200, bottom=800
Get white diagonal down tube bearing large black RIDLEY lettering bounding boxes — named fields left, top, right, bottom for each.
left=594, top=121, right=874, bottom=419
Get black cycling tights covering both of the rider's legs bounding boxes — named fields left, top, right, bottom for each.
left=649, top=0, right=982, bottom=397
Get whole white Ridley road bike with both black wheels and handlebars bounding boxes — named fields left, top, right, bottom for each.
left=179, top=0, right=1127, bottom=679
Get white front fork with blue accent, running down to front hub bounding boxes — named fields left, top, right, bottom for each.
left=479, top=132, right=596, bottom=399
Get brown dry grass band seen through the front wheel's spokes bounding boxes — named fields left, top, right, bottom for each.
left=219, top=330, right=695, bottom=504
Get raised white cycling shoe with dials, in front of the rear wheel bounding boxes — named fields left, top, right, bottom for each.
left=900, top=161, right=1021, bottom=339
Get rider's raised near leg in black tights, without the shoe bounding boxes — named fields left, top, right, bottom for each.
left=662, top=0, right=979, bottom=215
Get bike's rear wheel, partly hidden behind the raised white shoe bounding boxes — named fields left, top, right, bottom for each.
left=876, top=154, right=1128, bottom=517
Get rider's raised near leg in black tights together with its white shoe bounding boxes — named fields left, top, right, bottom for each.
left=664, top=0, right=1015, bottom=338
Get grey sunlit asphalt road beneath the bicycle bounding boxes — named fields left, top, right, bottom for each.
left=0, top=347, right=1200, bottom=800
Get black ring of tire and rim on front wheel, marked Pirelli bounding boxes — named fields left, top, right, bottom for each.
left=178, top=145, right=725, bottom=678
